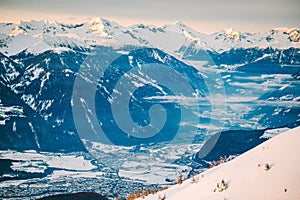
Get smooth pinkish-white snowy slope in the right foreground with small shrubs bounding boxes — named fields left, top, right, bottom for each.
left=145, top=127, right=300, bottom=200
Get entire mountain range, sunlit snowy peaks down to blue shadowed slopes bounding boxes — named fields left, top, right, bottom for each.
left=0, top=18, right=300, bottom=152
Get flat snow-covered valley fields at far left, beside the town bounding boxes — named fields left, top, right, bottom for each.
left=0, top=150, right=107, bottom=188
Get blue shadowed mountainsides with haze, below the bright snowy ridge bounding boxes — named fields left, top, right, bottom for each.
left=0, top=47, right=300, bottom=152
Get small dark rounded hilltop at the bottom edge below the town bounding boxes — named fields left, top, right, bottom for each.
left=40, top=192, right=108, bottom=200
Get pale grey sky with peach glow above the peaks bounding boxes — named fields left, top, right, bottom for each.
left=0, top=0, right=300, bottom=33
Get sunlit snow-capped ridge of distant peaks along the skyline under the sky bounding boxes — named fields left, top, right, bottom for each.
left=0, top=18, right=300, bottom=56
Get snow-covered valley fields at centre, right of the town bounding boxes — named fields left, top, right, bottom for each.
left=88, top=139, right=199, bottom=184
